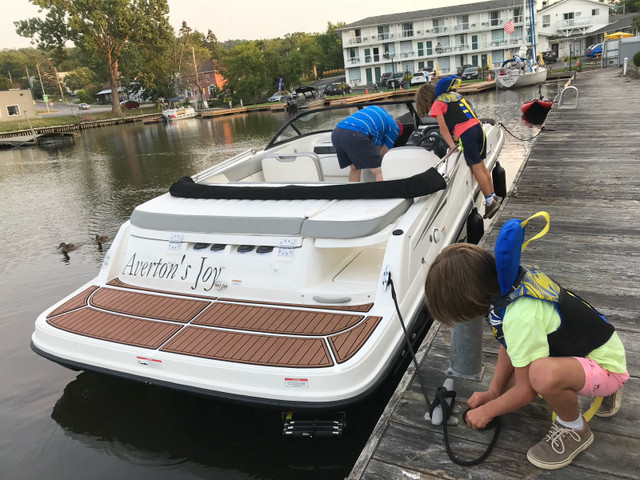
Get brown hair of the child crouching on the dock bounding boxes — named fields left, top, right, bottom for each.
left=425, top=243, right=500, bottom=326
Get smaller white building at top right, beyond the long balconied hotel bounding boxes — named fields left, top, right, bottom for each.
left=536, top=0, right=610, bottom=58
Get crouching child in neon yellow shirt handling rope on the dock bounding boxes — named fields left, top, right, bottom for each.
left=425, top=243, right=629, bottom=470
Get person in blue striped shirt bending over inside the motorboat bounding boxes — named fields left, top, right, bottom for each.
left=331, top=105, right=402, bottom=182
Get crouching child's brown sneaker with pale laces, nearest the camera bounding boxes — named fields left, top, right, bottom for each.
left=527, top=422, right=593, bottom=470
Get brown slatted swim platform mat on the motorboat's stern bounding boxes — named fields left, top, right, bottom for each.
left=47, top=279, right=381, bottom=368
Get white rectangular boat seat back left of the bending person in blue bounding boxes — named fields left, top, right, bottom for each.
left=262, top=153, right=323, bottom=183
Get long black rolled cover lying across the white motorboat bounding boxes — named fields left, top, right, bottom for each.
left=169, top=167, right=447, bottom=200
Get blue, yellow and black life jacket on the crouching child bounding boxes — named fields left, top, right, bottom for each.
left=487, top=212, right=614, bottom=357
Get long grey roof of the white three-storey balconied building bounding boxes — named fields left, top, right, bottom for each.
left=336, top=0, right=522, bottom=31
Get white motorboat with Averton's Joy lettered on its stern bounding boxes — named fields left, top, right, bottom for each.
left=32, top=101, right=503, bottom=410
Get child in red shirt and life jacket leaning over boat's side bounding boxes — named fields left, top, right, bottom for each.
left=416, top=79, right=502, bottom=218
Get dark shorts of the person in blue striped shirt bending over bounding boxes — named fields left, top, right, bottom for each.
left=331, top=127, right=382, bottom=170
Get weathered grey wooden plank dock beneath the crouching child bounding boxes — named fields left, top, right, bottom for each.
left=348, top=67, right=640, bottom=480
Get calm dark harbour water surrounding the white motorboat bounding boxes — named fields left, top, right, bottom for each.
left=0, top=85, right=557, bottom=480
